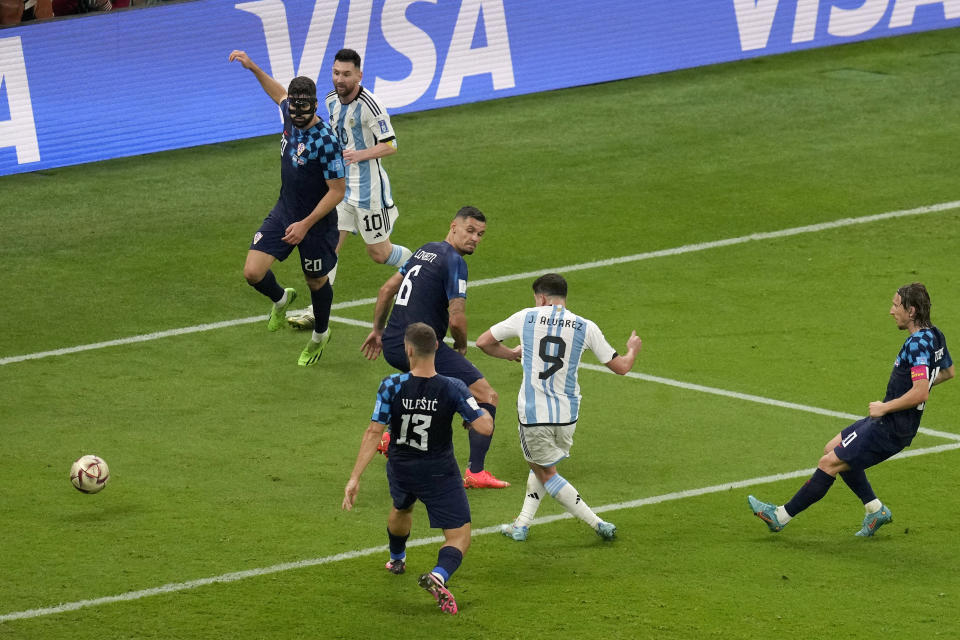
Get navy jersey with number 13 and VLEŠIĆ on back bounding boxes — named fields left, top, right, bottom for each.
left=372, top=372, right=483, bottom=459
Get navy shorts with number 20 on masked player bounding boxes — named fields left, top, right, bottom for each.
left=250, top=207, right=340, bottom=278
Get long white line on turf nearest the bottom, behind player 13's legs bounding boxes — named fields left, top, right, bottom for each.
left=0, top=442, right=960, bottom=623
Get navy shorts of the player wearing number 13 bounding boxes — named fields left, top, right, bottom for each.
left=387, top=454, right=470, bottom=529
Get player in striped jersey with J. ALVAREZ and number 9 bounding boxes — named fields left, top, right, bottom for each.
left=477, top=273, right=642, bottom=541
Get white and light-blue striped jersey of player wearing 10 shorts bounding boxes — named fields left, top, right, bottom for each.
left=326, top=85, right=397, bottom=211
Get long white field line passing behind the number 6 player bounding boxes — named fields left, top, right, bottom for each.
left=0, top=200, right=960, bottom=366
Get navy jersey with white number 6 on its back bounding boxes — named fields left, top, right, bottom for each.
left=383, top=241, right=467, bottom=342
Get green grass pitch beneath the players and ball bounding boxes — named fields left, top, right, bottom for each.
left=0, top=29, right=960, bottom=640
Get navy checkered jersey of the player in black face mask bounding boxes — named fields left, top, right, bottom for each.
left=274, top=100, right=345, bottom=226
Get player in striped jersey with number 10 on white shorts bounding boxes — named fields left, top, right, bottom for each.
left=290, top=49, right=411, bottom=329
